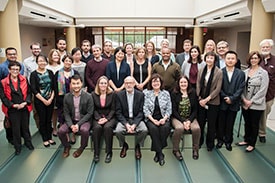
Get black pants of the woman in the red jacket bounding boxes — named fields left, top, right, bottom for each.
left=8, top=108, right=31, bottom=149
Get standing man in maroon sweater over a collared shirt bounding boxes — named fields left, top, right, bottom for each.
left=85, top=45, right=109, bottom=92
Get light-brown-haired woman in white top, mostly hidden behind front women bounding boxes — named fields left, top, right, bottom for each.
left=46, top=49, right=63, bottom=137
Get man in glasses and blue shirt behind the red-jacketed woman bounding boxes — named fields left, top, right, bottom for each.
left=0, top=47, right=24, bottom=144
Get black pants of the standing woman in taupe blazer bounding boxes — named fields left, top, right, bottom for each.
left=198, top=104, right=219, bottom=149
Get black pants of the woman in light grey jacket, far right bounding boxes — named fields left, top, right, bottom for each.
left=242, top=108, right=263, bottom=147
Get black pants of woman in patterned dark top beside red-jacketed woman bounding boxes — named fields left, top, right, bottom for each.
left=34, top=99, right=54, bottom=142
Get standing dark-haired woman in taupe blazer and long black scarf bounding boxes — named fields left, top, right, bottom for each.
left=196, top=52, right=222, bottom=151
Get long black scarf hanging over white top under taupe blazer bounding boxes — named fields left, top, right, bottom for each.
left=199, top=66, right=215, bottom=98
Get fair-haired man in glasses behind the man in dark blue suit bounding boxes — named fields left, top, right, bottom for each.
left=216, top=41, right=241, bottom=69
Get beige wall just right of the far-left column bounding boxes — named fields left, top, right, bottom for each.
left=20, top=24, right=55, bottom=59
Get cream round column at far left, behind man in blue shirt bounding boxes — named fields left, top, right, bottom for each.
left=0, top=0, right=22, bottom=62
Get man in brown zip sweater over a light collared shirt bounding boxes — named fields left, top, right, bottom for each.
left=152, top=48, right=181, bottom=92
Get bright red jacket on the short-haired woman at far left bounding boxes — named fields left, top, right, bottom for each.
left=1, top=74, right=32, bottom=116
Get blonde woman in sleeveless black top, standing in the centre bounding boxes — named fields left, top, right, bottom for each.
left=133, top=47, right=152, bottom=91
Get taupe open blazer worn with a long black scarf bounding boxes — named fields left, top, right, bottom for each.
left=196, top=66, right=222, bottom=105
